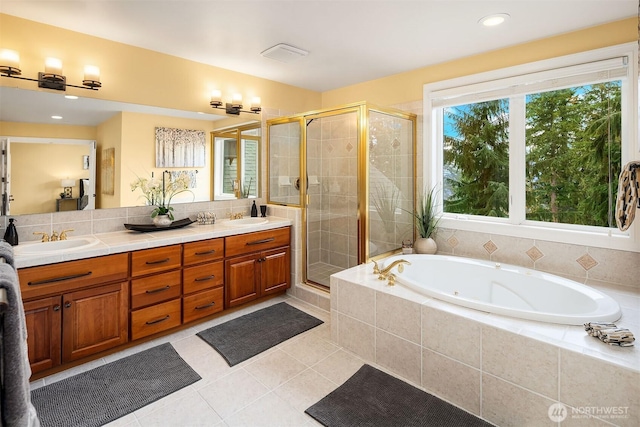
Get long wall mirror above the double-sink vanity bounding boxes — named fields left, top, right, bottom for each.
left=0, top=86, right=260, bottom=215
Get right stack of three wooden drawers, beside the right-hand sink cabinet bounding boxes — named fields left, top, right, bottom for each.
left=182, top=238, right=224, bottom=323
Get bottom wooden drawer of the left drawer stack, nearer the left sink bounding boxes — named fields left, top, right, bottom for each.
left=131, top=298, right=182, bottom=340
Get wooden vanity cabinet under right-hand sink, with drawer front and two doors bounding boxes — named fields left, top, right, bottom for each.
left=225, top=227, right=291, bottom=307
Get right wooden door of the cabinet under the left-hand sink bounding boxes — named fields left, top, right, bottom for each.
left=62, top=283, right=129, bottom=362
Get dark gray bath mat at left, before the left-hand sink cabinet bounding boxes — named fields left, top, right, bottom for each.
left=31, top=344, right=200, bottom=427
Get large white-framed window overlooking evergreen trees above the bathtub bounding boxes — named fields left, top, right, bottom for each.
left=425, top=46, right=637, bottom=249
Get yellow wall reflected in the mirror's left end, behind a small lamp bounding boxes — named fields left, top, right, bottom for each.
left=10, top=143, right=89, bottom=215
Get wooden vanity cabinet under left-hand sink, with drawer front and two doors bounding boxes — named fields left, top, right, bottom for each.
left=18, top=254, right=129, bottom=373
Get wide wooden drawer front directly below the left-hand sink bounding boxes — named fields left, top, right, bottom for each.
left=18, top=254, right=129, bottom=300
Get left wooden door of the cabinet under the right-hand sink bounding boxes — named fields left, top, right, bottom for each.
left=225, top=254, right=260, bottom=308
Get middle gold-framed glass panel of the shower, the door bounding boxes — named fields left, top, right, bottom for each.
left=306, top=111, right=358, bottom=286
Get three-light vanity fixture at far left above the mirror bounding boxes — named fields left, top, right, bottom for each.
left=0, top=49, right=102, bottom=91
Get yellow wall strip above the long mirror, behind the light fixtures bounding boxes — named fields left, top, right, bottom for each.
left=0, top=14, right=321, bottom=118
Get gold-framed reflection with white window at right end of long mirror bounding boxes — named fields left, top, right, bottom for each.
left=211, top=123, right=261, bottom=200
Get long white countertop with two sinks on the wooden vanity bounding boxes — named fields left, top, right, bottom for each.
left=14, top=216, right=292, bottom=268
